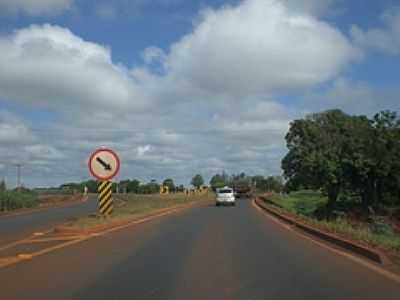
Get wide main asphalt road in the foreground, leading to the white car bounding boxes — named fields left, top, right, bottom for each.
left=0, top=200, right=400, bottom=300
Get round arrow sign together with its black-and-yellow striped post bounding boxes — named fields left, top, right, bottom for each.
left=88, top=148, right=120, bottom=216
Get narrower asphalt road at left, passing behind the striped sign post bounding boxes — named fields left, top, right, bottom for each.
left=0, top=196, right=97, bottom=246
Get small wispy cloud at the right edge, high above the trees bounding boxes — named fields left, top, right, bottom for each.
left=350, top=7, right=400, bottom=55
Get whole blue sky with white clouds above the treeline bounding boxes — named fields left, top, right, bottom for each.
left=0, top=0, right=400, bottom=187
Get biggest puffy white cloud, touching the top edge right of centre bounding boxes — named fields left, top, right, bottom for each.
left=165, top=0, right=357, bottom=97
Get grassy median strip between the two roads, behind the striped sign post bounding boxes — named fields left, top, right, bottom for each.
left=69, top=193, right=215, bottom=229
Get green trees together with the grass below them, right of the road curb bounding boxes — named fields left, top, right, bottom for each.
left=266, top=110, right=400, bottom=255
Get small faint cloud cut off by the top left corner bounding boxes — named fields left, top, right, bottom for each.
left=0, top=0, right=74, bottom=16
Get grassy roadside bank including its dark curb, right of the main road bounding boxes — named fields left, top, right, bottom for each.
left=257, top=193, right=400, bottom=266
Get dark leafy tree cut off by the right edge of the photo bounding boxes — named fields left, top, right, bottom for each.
left=347, top=111, right=400, bottom=206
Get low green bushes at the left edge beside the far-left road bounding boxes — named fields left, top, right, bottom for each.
left=0, top=191, right=39, bottom=211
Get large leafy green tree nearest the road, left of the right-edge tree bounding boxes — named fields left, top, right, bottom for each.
left=282, top=110, right=350, bottom=208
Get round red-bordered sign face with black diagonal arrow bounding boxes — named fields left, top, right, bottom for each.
left=88, top=148, right=120, bottom=181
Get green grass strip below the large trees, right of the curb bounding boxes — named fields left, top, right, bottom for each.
left=262, top=191, right=400, bottom=255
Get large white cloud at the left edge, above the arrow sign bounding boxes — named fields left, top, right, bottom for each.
left=0, top=25, right=145, bottom=112
